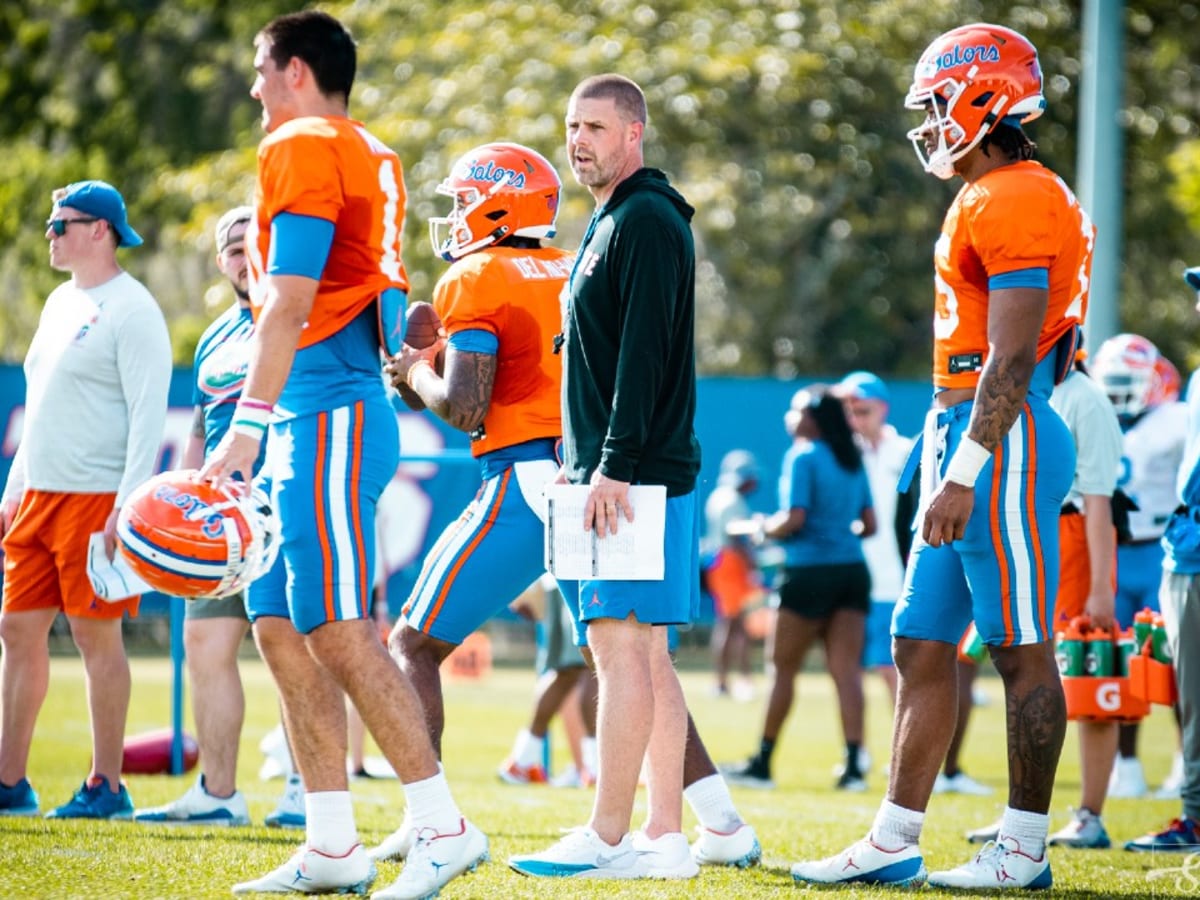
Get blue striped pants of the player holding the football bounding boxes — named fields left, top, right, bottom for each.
left=402, top=460, right=558, bottom=644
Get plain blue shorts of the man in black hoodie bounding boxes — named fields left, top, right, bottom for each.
left=558, top=491, right=700, bottom=647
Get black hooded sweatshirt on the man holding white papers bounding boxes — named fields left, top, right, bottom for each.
left=563, top=168, right=700, bottom=497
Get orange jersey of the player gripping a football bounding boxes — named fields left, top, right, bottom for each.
left=433, top=247, right=574, bottom=456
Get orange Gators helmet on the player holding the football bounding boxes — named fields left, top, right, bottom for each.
left=430, top=143, right=563, bottom=262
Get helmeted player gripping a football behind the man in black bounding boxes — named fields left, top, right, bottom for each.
left=371, top=143, right=762, bottom=878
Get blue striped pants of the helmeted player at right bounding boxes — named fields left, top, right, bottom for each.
left=893, top=394, right=1075, bottom=647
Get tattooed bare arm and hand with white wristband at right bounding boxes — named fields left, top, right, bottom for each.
left=922, top=288, right=1049, bottom=547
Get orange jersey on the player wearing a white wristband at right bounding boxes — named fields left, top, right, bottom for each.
left=934, top=161, right=1096, bottom=389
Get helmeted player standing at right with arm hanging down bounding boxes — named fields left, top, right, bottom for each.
left=792, top=24, right=1094, bottom=889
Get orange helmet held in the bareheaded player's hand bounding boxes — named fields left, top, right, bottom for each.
left=116, top=469, right=280, bottom=599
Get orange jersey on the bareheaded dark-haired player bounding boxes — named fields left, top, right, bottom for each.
left=246, top=116, right=408, bottom=348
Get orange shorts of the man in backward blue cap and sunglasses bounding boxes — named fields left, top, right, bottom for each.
left=4, top=490, right=140, bottom=619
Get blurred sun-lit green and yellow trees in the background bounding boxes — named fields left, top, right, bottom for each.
left=0, top=0, right=1200, bottom=376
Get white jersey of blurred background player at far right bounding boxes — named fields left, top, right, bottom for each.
left=1117, top=403, right=1188, bottom=541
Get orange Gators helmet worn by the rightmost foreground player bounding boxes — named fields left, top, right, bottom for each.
left=904, top=23, right=1046, bottom=180
